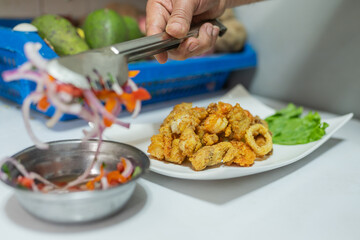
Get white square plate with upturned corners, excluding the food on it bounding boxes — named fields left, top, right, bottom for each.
left=104, top=85, right=353, bottom=180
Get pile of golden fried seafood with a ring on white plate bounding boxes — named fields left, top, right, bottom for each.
left=148, top=102, right=272, bottom=171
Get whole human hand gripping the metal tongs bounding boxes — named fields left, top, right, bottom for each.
left=146, top=0, right=227, bottom=63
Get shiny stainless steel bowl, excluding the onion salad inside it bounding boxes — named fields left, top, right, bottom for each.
left=0, top=140, right=150, bottom=223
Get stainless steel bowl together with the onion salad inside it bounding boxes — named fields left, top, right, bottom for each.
left=0, top=140, right=150, bottom=223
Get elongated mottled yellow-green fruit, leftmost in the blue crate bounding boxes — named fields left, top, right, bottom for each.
left=32, top=14, right=89, bottom=56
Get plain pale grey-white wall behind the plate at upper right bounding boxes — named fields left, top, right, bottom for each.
left=236, top=0, right=360, bottom=118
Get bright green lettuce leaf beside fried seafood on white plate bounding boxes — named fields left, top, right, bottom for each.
left=265, top=103, right=329, bottom=145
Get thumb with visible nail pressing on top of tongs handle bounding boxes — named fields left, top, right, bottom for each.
left=166, top=1, right=195, bottom=38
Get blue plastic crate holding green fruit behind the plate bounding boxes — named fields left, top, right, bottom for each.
left=0, top=19, right=257, bottom=120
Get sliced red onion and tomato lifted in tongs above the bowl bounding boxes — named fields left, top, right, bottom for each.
left=3, top=42, right=151, bottom=149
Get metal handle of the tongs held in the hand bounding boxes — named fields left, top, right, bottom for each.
left=110, top=19, right=227, bottom=62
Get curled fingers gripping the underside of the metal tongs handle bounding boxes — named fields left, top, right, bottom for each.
left=168, top=23, right=220, bottom=60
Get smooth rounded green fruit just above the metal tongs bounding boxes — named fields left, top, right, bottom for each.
left=83, top=8, right=128, bottom=48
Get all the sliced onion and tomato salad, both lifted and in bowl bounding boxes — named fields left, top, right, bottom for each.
left=0, top=43, right=150, bottom=193
